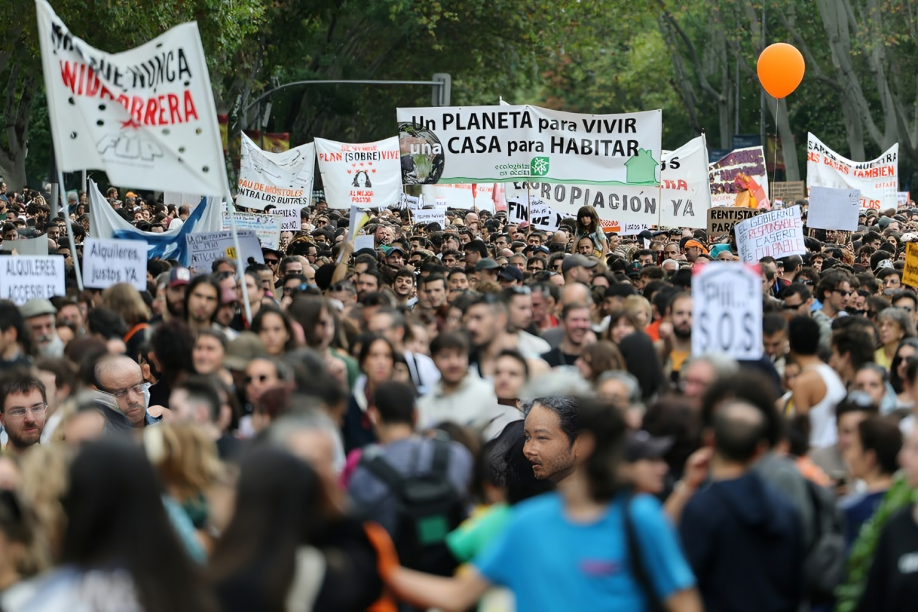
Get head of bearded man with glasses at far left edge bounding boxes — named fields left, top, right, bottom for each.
left=0, top=370, right=48, bottom=456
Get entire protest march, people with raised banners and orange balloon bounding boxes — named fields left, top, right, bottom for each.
left=0, top=0, right=918, bottom=612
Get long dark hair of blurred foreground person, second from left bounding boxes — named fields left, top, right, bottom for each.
left=210, top=447, right=332, bottom=612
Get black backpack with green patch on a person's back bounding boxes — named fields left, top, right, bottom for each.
left=360, top=438, right=466, bottom=576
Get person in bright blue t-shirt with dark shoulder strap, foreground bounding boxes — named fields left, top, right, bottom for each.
left=388, top=398, right=702, bottom=612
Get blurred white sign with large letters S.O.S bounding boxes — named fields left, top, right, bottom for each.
left=692, top=262, right=764, bottom=360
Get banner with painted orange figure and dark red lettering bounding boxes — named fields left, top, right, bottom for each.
left=708, top=146, right=771, bottom=209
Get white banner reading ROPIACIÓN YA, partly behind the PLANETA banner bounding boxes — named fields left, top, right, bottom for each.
left=506, top=136, right=711, bottom=228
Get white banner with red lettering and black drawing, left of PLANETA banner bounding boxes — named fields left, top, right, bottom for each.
left=315, top=136, right=402, bottom=209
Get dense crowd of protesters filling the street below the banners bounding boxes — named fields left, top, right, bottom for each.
left=0, top=180, right=918, bottom=612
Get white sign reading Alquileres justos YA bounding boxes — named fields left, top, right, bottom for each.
left=83, top=238, right=147, bottom=291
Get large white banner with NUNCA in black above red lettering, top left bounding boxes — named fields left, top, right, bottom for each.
left=36, top=0, right=227, bottom=196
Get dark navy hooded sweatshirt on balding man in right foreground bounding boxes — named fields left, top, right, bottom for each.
left=679, top=472, right=804, bottom=612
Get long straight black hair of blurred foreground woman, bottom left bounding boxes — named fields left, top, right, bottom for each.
left=61, top=438, right=216, bottom=612
